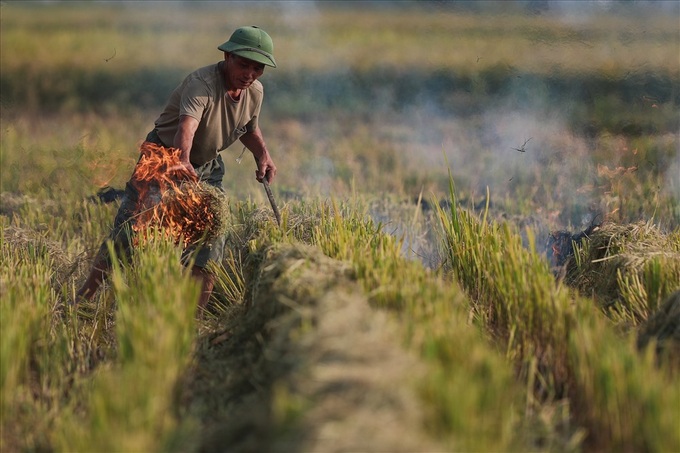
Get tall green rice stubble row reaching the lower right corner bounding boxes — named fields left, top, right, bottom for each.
left=440, top=179, right=680, bottom=451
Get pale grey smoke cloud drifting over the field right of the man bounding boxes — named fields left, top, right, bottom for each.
left=406, top=82, right=595, bottom=225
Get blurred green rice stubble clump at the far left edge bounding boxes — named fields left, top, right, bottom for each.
left=0, top=217, right=71, bottom=451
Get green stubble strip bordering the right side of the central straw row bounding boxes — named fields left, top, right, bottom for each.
left=314, top=200, right=535, bottom=451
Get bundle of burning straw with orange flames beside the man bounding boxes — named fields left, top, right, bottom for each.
left=132, top=142, right=227, bottom=247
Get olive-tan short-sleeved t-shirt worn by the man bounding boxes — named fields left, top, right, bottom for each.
left=155, top=62, right=264, bottom=166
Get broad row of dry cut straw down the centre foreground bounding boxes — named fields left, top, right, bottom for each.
left=184, top=245, right=442, bottom=452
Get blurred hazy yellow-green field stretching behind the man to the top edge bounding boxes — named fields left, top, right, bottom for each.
left=1, top=2, right=680, bottom=233
